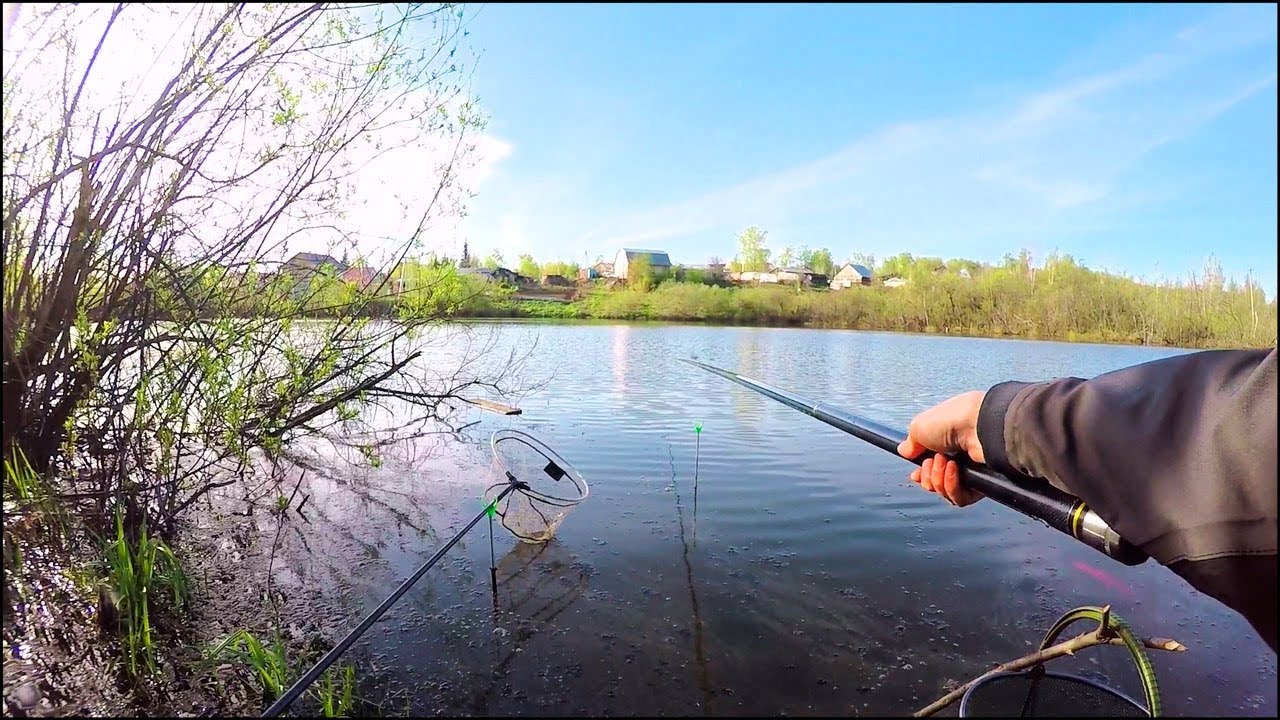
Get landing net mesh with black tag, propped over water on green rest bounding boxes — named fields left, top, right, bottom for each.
left=485, top=430, right=588, bottom=543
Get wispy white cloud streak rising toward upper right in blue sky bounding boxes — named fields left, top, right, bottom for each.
left=577, top=10, right=1276, bottom=263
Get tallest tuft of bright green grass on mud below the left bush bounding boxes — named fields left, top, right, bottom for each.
left=104, top=510, right=191, bottom=676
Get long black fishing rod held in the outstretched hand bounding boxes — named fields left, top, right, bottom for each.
left=685, top=360, right=1147, bottom=565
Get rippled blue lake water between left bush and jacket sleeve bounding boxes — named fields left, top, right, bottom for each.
left=249, top=324, right=1276, bottom=715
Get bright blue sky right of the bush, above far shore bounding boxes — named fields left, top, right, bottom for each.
left=452, top=5, right=1277, bottom=296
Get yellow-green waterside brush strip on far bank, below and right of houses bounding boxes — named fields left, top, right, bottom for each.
left=445, top=244, right=1276, bottom=347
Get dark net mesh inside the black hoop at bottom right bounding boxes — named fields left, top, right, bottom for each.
left=960, top=673, right=1148, bottom=717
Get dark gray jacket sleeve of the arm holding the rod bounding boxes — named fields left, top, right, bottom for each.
left=978, top=348, right=1277, bottom=650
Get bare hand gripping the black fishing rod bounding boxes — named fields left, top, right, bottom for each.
left=897, top=391, right=987, bottom=507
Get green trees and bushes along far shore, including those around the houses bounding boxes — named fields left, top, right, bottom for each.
left=267, top=227, right=1276, bottom=347
